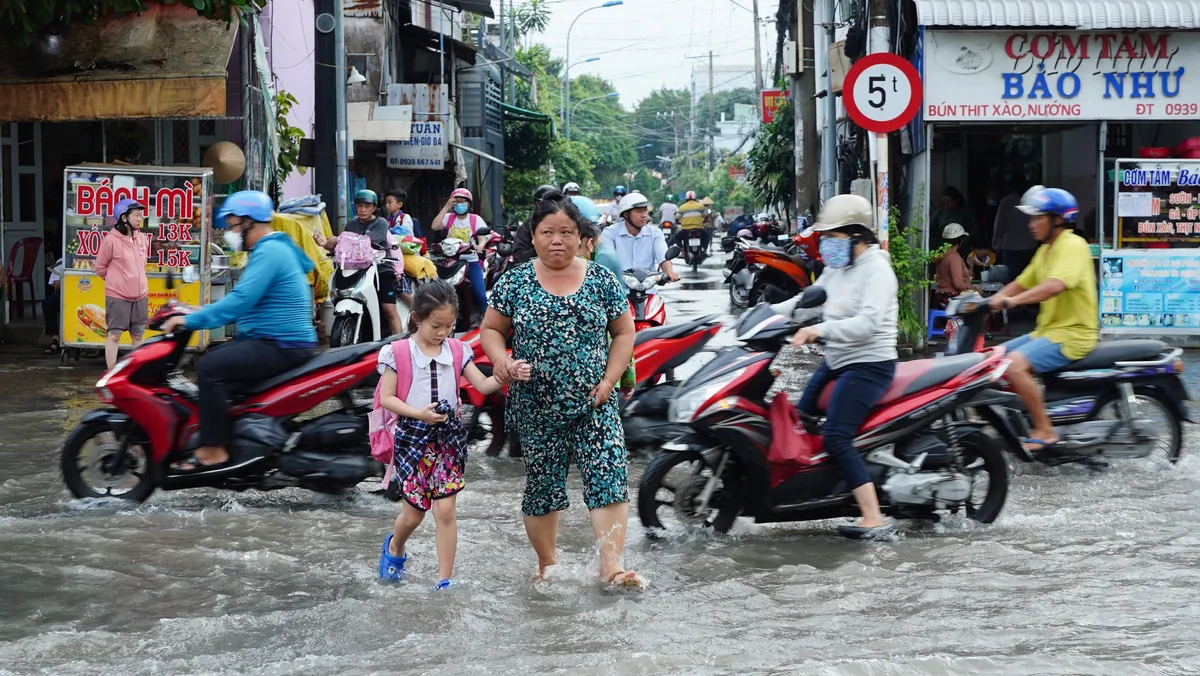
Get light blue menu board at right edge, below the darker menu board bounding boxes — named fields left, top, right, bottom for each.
left=1100, top=250, right=1200, bottom=335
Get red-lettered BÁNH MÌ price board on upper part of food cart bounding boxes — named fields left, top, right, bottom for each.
left=62, top=168, right=211, bottom=273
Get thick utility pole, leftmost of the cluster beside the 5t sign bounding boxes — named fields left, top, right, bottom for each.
left=792, top=0, right=832, bottom=226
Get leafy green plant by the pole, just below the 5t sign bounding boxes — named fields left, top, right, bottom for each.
left=888, top=185, right=950, bottom=343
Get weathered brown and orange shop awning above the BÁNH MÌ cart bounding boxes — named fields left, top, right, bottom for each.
left=0, top=4, right=238, bottom=122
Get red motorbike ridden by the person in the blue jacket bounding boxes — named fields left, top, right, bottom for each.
left=61, top=300, right=383, bottom=502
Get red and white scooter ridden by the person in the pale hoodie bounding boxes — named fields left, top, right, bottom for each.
left=637, top=287, right=1010, bottom=534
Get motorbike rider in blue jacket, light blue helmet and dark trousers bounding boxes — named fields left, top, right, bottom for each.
left=162, top=190, right=317, bottom=472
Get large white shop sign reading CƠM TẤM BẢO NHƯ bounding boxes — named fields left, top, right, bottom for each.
left=924, top=29, right=1200, bottom=121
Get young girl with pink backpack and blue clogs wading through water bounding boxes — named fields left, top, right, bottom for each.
left=379, top=280, right=529, bottom=590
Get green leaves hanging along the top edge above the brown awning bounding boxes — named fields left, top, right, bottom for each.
left=0, top=0, right=263, bottom=47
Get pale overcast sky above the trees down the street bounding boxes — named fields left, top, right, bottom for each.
left=534, top=0, right=779, bottom=109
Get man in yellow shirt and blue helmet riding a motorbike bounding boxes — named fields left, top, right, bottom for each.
left=988, top=185, right=1099, bottom=451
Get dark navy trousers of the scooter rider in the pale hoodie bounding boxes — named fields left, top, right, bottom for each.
left=796, top=361, right=896, bottom=490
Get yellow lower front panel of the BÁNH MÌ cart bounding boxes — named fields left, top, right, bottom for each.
left=60, top=270, right=208, bottom=347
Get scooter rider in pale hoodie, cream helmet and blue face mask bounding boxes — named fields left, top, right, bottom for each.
left=792, top=195, right=900, bottom=539
